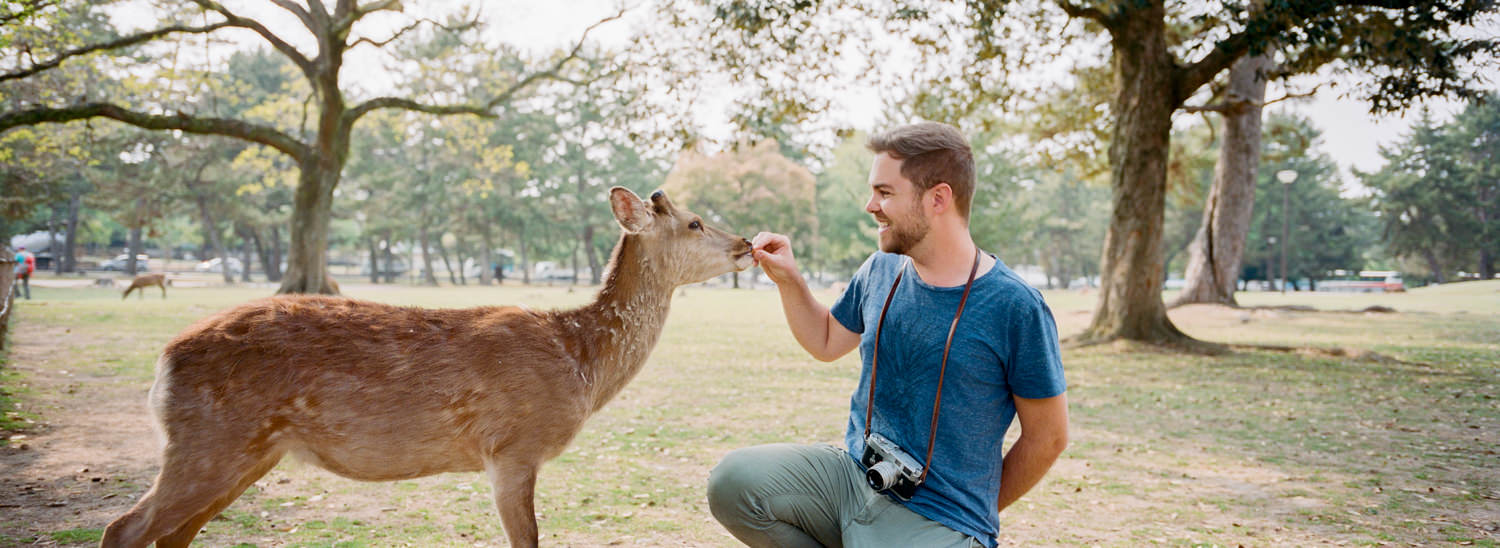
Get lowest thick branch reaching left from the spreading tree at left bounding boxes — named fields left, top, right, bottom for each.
left=0, top=102, right=311, bottom=162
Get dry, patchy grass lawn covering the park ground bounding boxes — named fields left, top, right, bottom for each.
left=0, top=282, right=1500, bottom=546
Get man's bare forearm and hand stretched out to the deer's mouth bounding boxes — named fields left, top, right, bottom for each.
left=752, top=233, right=860, bottom=362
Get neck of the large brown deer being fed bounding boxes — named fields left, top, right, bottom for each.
left=563, top=234, right=675, bottom=411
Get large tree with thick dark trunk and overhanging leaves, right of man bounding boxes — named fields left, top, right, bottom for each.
left=690, top=0, right=1496, bottom=347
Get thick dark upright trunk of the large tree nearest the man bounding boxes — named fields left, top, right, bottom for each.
left=1077, top=5, right=1193, bottom=344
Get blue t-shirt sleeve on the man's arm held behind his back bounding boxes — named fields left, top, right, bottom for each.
left=1005, top=292, right=1068, bottom=399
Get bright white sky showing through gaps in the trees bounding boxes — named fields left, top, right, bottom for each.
left=108, top=0, right=1497, bottom=183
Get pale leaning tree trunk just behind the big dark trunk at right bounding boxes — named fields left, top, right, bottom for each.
left=1172, top=56, right=1271, bottom=306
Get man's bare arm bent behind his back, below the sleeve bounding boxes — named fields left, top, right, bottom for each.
left=999, top=393, right=1068, bottom=512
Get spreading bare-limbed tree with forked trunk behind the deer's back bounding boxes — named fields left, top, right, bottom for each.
left=0, top=0, right=618, bottom=293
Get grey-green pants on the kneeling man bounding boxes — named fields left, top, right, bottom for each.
left=708, top=443, right=983, bottom=548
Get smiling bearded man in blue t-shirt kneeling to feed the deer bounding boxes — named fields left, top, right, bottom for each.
left=708, top=123, right=1068, bottom=548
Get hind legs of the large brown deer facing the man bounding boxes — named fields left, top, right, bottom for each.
left=99, top=438, right=281, bottom=548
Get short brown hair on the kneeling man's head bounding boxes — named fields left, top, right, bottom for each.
left=866, top=122, right=974, bottom=219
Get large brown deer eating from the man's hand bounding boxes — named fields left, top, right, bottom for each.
left=102, top=188, right=753, bottom=546
